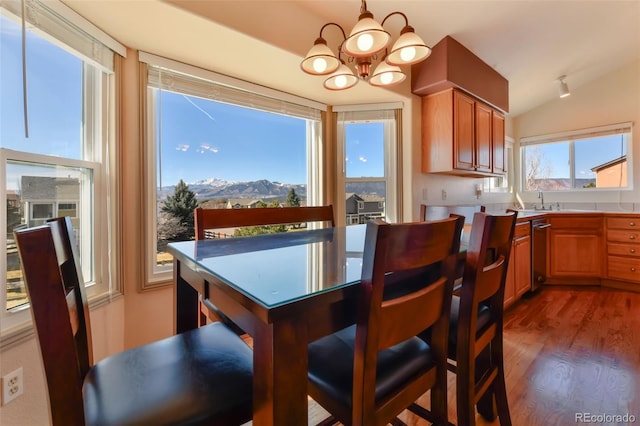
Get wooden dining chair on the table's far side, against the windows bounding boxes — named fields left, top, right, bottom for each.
left=193, top=205, right=335, bottom=328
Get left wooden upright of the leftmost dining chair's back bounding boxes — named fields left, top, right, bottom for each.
left=14, top=221, right=87, bottom=425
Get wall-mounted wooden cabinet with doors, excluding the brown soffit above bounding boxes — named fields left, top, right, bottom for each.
left=422, top=89, right=505, bottom=176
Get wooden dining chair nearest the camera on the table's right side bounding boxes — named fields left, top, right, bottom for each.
left=308, top=218, right=459, bottom=426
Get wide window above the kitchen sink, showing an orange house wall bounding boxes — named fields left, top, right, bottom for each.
left=520, top=123, right=632, bottom=191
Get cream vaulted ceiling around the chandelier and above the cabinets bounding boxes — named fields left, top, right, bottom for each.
left=62, top=0, right=640, bottom=116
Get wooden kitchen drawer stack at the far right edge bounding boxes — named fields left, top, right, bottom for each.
left=606, top=215, right=640, bottom=284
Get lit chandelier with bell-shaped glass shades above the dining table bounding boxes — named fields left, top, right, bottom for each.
left=300, top=0, right=431, bottom=90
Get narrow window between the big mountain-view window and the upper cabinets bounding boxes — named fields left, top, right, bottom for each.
left=337, top=105, right=399, bottom=225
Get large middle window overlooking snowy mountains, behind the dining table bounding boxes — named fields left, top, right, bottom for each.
left=141, top=54, right=323, bottom=286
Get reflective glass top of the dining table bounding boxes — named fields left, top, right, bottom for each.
left=170, top=225, right=366, bottom=308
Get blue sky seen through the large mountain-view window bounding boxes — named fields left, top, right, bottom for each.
left=160, top=91, right=307, bottom=186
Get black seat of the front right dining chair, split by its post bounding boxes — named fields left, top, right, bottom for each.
left=309, top=325, right=434, bottom=407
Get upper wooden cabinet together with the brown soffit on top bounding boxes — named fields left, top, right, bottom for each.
left=411, top=36, right=509, bottom=177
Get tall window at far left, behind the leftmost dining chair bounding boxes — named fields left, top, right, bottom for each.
left=0, top=0, right=124, bottom=330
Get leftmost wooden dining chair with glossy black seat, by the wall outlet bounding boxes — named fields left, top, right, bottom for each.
left=14, top=218, right=253, bottom=426
